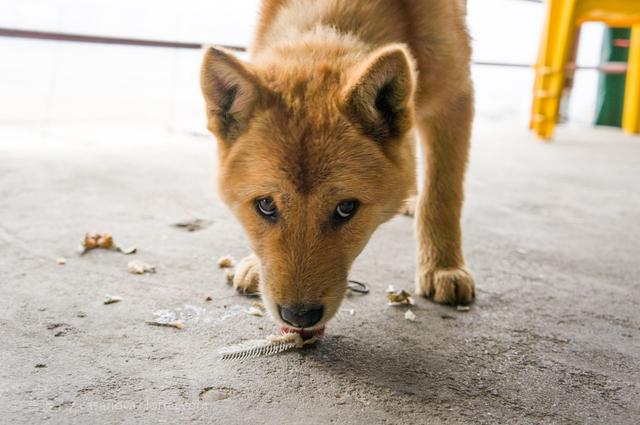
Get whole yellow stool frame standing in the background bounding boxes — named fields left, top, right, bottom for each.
left=530, top=0, right=640, bottom=140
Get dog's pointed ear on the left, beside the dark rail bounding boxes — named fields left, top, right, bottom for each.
left=200, top=47, right=259, bottom=143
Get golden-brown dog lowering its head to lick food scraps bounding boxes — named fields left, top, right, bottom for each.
left=201, top=0, right=475, bottom=329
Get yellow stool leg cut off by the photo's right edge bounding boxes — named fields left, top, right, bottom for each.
left=622, top=24, right=640, bottom=134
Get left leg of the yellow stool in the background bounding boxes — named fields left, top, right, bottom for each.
left=531, top=0, right=576, bottom=139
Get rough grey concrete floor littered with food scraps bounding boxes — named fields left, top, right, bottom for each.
left=0, top=123, right=640, bottom=424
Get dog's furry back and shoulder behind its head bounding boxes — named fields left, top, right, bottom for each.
left=252, top=0, right=471, bottom=112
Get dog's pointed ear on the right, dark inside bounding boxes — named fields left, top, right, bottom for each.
left=343, top=45, right=416, bottom=142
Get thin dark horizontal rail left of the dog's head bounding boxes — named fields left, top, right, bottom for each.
left=0, top=28, right=247, bottom=52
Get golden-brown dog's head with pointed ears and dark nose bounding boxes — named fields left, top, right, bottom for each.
left=201, top=45, right=415, bottom=329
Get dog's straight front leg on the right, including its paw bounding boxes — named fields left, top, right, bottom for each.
left=416, top=94, right=475, bottom=304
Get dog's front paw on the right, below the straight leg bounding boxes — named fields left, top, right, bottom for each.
left=416, top=267, right=476, bottom=305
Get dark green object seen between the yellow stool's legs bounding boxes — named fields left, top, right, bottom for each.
left=596, top=28, right=631, bottom=127
